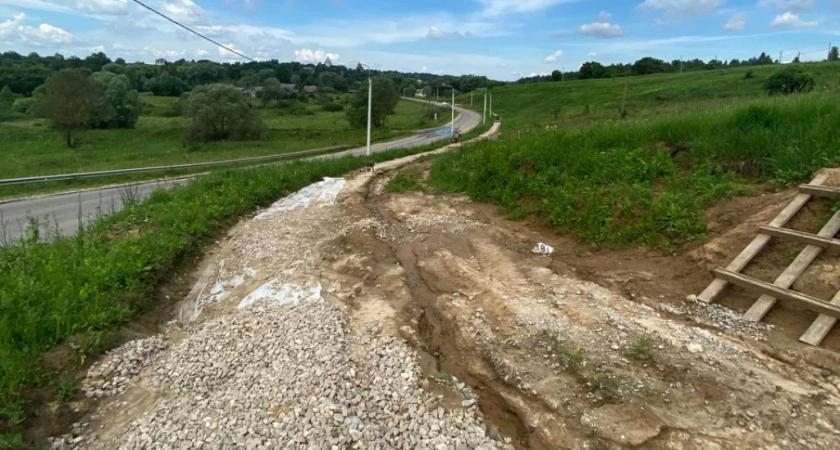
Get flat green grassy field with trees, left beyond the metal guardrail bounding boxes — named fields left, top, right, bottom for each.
left=0, top=95, right=440, bottom=178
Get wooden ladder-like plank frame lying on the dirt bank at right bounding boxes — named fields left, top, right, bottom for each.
left=697, top=174, right=840, bottom=345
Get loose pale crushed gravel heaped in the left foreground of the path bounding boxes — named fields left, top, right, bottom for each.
left=53, top=300, right=512, bottom=450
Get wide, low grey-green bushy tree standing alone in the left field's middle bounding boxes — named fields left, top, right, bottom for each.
left=184, top=84, right=268, bottom=142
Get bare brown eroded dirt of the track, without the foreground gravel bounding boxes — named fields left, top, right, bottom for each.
left=49, top=138, right=840, bottom=450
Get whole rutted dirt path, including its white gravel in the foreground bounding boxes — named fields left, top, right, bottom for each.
left=49, top=134, right=840, bottom=450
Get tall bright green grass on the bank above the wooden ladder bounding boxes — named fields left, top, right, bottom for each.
left=430, top=95, right=840, bottom=247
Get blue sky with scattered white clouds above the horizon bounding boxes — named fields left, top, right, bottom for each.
left=0, top=0, right=840, bottom=80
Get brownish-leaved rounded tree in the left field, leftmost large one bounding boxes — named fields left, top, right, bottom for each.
left=34, top=69, right=102, bottom=148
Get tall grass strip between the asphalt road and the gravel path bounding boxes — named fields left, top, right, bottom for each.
left=0, top=146, right=442, bottom=430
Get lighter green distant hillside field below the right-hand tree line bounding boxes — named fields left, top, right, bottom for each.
left=458, top=62, right=840, bottom=132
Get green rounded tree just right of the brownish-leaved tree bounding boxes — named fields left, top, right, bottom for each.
left=90, top=71, right=143, bottom=128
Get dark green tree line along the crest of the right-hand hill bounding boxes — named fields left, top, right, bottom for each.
left=517, top=47, right=838, bottom=84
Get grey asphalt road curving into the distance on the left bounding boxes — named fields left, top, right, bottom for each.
left=0, top=106, right=481, bottom=245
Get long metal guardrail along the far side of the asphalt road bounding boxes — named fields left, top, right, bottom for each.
left=0, top=145, right=353, bottom=186
